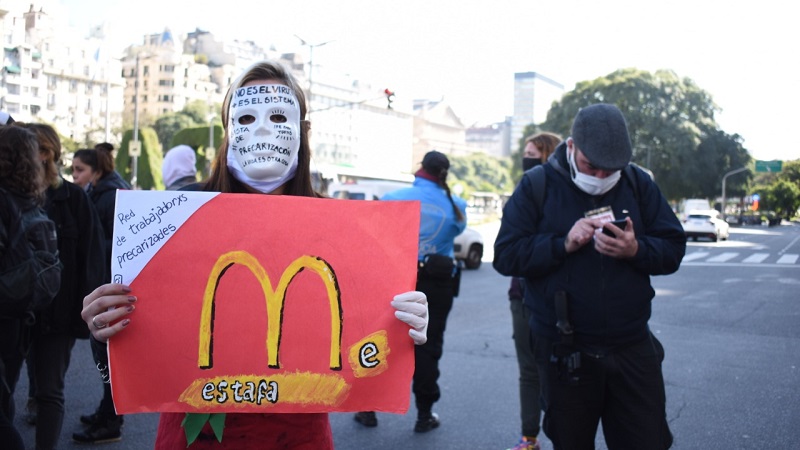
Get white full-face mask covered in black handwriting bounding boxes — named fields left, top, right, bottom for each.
left=228, top=84, right=300, bottom=192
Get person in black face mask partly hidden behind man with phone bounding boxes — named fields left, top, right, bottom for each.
left=508, top=132, right=561, bottom=450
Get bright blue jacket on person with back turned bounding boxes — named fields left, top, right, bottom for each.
left=381, top=177, right=467, bottom=261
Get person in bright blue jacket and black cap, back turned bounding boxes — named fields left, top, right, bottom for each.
left=355, top=150, right=467, bottom=433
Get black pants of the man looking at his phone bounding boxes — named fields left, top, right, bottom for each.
left=535, top=335, right=672, bottom=450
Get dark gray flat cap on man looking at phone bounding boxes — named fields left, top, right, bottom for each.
left=572, top=103, right=632, bottom=170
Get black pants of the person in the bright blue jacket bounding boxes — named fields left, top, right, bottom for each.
left=412, top=274, right=453, bottom=414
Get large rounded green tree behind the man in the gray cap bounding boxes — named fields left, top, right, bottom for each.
left=541, top=69, right=751, bottom=200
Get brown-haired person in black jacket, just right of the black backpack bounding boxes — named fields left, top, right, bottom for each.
left=17, top=123, right=108, bottom=450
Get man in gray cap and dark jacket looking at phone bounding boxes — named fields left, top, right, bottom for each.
left=494, top=104, right=686, bottom=450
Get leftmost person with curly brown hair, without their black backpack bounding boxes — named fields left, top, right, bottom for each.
left=0, top=126, right=47, bottom=450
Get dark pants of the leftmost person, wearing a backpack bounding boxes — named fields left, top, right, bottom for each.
left=0, top=319, right=28, bottom=450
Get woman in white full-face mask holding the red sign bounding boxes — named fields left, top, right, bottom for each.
left=82, top=61, right=428, bottom=449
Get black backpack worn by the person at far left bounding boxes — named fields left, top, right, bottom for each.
left=0, top=188, right=63, bottom=318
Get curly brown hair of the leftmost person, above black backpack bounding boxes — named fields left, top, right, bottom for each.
left=0, top=126, right=47, bottom=202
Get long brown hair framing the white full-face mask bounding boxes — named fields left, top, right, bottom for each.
left=205, top=61, right=320, bottom=197
